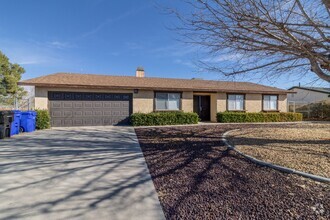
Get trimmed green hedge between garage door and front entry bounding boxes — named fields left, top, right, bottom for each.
left=131, top=112, right=199, bottom=126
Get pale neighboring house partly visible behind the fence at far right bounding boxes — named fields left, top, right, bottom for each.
left=288, top=86, right=330, bottom=104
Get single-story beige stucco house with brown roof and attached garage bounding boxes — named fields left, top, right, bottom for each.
left=19, top=69, right=290, bottom=126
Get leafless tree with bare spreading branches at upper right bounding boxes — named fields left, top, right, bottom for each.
left=175, top=0, right=330, bottom=82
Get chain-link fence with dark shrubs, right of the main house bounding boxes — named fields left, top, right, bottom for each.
left=288, top=100, right=330, bottom=121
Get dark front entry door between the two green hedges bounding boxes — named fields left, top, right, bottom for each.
left=194, top=95, right=211, bottom=121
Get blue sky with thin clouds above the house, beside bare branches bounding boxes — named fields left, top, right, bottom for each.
left=0, top=0, right=329, bottom=89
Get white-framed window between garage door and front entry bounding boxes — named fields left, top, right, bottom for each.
left=156, top=92, right=181, bottom=110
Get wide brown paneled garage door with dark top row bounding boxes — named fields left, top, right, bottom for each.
left=48, top=92, right=132, bottom=127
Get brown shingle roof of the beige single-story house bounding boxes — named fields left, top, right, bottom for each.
left=19, top=73, right=289, bottom=94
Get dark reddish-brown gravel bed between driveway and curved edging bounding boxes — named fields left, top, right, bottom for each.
left=136, top=124, right=330, bottom=219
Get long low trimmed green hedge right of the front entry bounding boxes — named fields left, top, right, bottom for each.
left=217, top=112, right=302, bottom=123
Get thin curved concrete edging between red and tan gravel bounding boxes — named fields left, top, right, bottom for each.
left=222, top=129, right=330, bottom=183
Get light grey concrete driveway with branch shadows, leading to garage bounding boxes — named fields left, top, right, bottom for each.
left=0, top=126, right=164, bottom=220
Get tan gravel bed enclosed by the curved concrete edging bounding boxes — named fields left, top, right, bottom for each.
left=229, top=124, right=330, bottom=177
